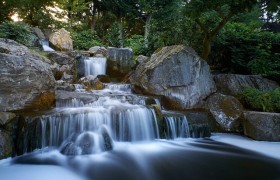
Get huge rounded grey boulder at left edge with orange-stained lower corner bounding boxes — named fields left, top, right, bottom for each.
left=0, top=39, right=55, bottom=111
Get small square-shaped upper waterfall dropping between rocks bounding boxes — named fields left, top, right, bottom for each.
left=84, top=57, right=107, bottom=76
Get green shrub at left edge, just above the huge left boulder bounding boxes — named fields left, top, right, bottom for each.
left=0, top=21, right=33, bottom=46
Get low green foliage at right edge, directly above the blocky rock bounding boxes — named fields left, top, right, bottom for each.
left=240, top=87, right=280, bottom=112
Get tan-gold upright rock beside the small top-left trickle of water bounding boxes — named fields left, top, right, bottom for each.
left=49, top=28, right=73, bottom=51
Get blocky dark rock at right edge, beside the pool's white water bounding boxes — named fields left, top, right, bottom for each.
left=244, top=111, right=280, bottom=141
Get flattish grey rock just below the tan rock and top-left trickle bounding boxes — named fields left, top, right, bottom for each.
left=47, top=52, right=74, bottom=65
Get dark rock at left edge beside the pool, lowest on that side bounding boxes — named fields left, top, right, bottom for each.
left=0, top=129, right=13, bottom=159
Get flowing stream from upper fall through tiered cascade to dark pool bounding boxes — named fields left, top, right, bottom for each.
left=0, top=58, right=280, bottom=180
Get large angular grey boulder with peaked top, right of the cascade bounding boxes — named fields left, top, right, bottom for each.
left=129, top=45, right=216, bottom=109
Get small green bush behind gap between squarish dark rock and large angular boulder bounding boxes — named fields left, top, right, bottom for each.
left=125, top=34, right=144, bottom=55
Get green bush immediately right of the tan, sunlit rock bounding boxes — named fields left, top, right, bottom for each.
left=72, top=29, right=102, bottom=50
